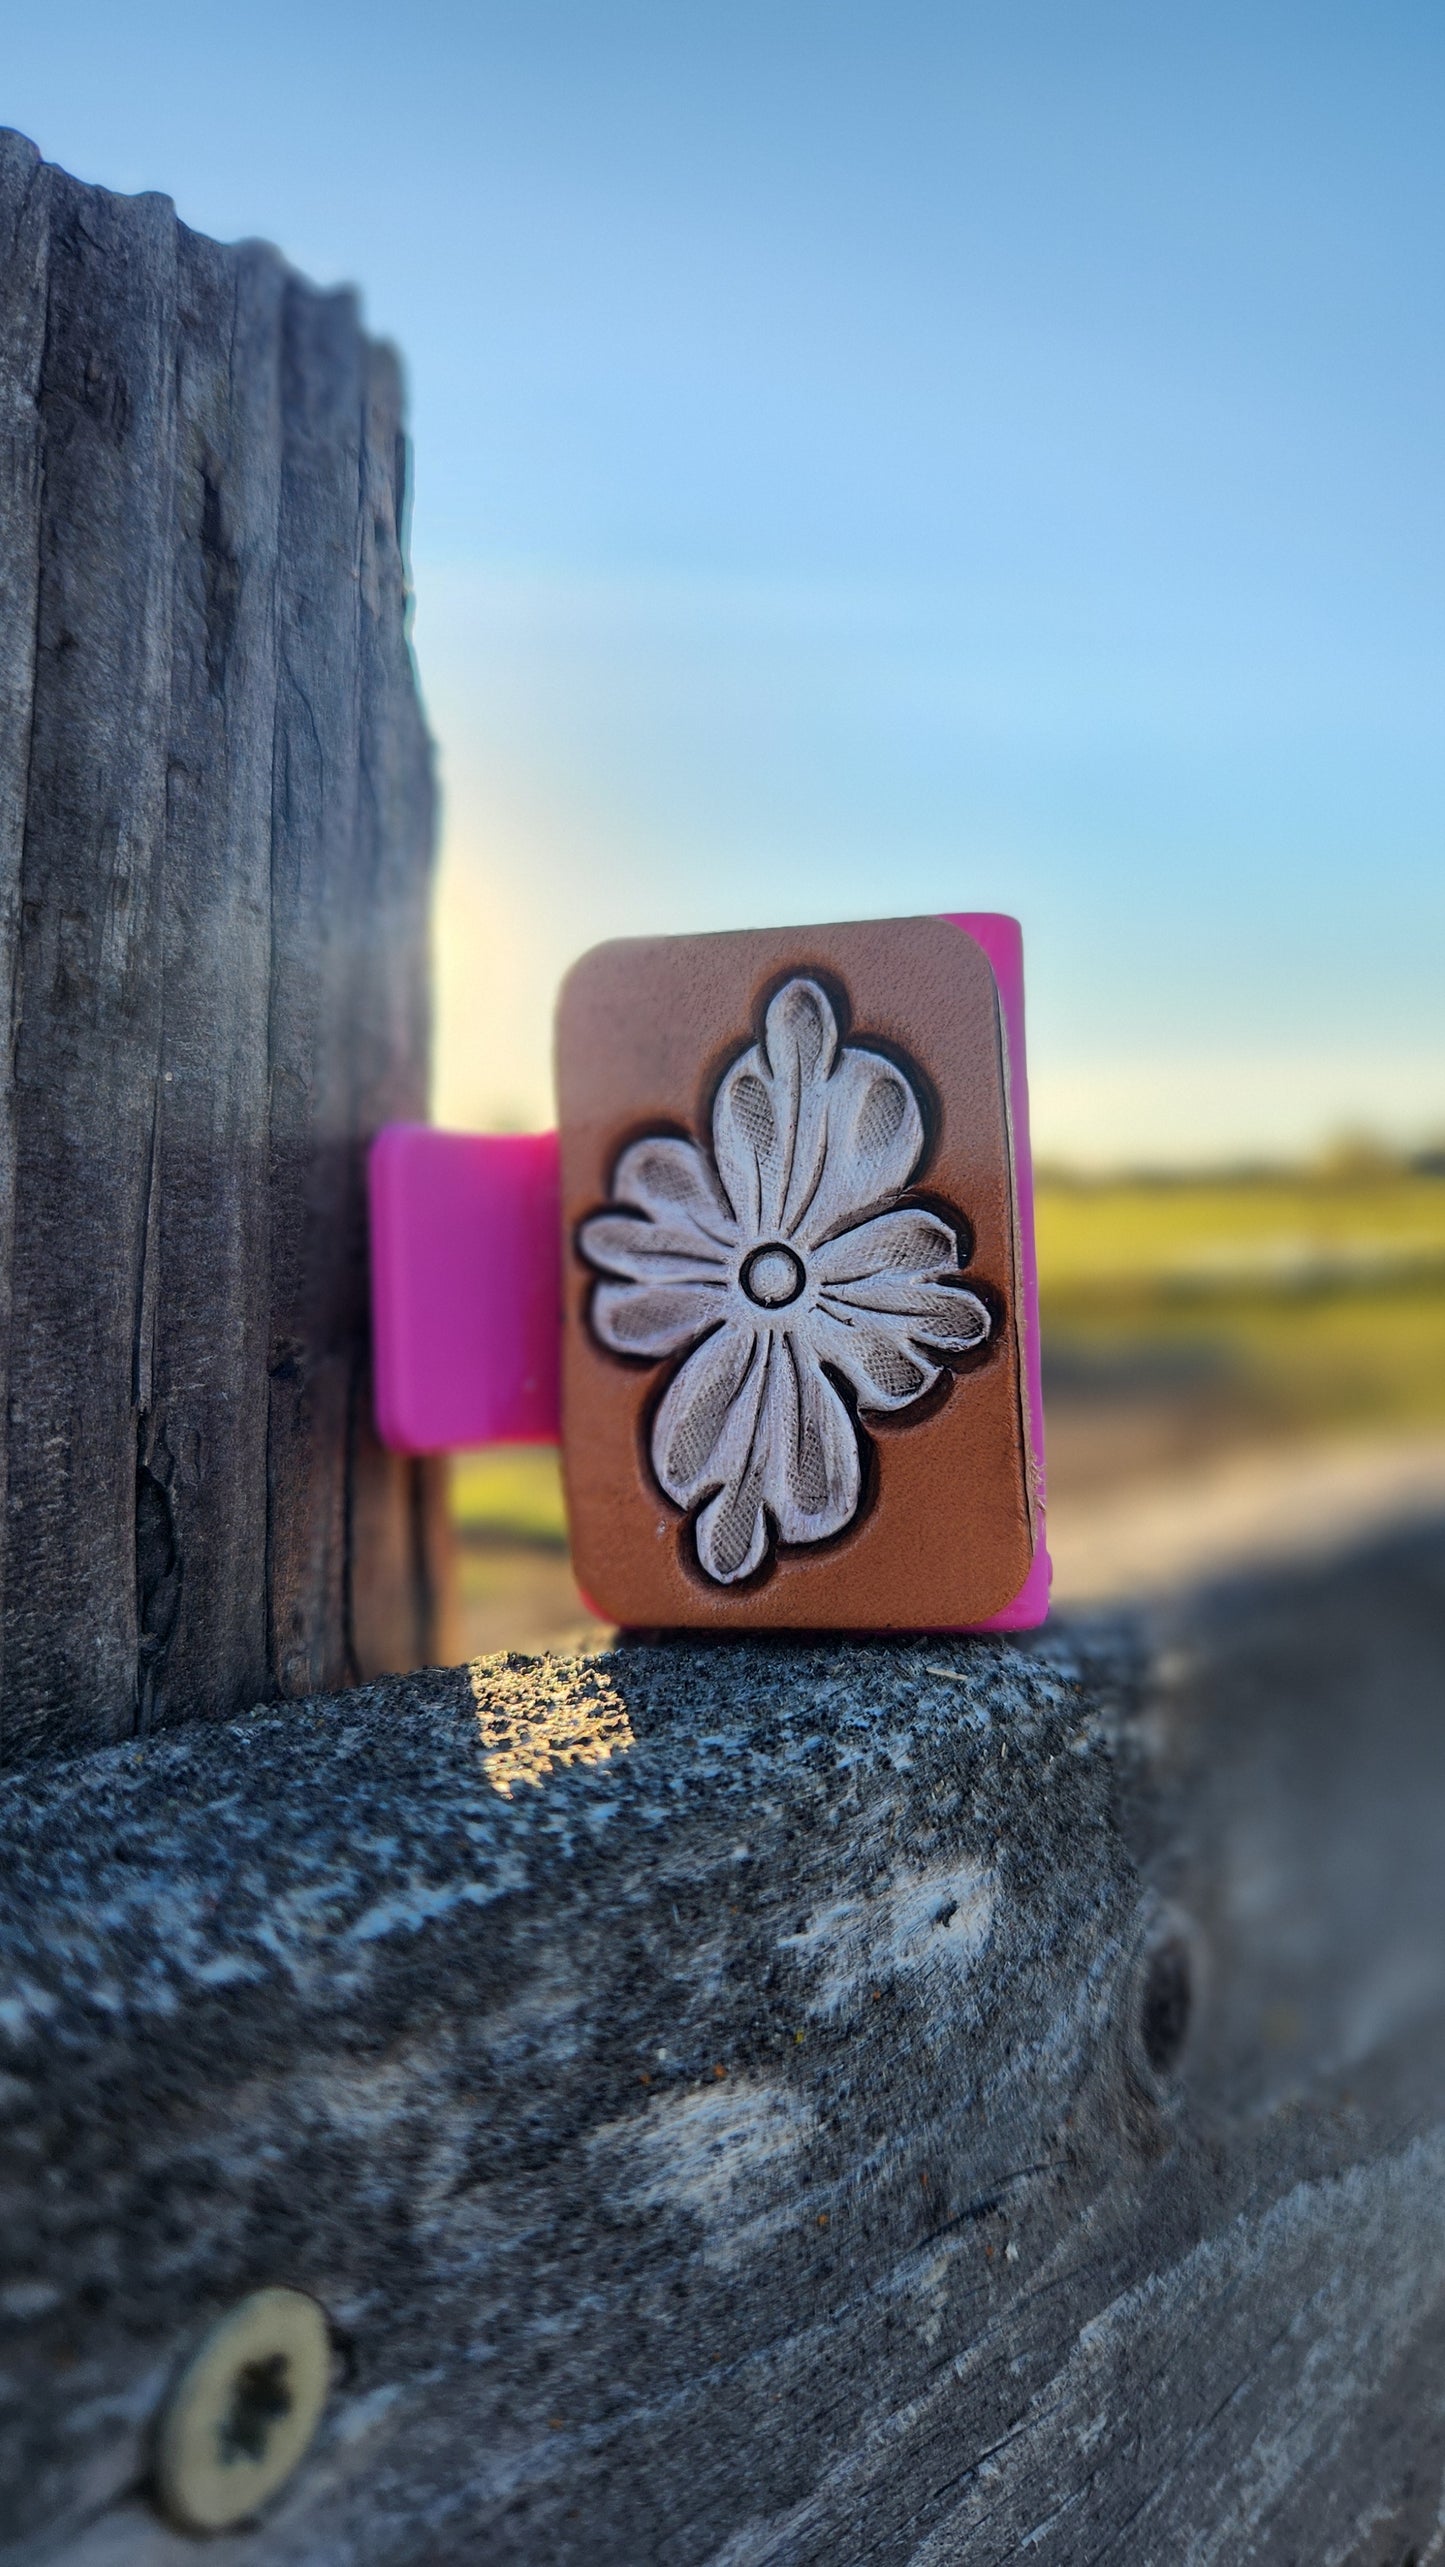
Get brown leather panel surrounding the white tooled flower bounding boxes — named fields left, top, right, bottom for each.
left=557, top=919, right=1034, bottom=1633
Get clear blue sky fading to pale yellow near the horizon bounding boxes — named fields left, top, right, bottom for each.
left=0, top=0, right=1445, bottom=1160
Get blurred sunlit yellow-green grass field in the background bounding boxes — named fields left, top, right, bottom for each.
left=454, top=1165, right=1445, bottom=1545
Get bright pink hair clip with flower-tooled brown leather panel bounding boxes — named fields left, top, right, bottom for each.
left=372, top=914, right=1047, bottom=1630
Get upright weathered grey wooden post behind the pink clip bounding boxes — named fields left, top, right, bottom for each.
left=0, top=133, right=441, bottom=1758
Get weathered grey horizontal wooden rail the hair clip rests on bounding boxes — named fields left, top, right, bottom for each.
left=0, top=1527, right=1445, bottom=2567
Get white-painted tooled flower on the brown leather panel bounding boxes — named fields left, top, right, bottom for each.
left=577, top=978, right=991, bottom=1586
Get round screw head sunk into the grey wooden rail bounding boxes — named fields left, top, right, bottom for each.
left=154, top=2287, right=331, bottom=2531
